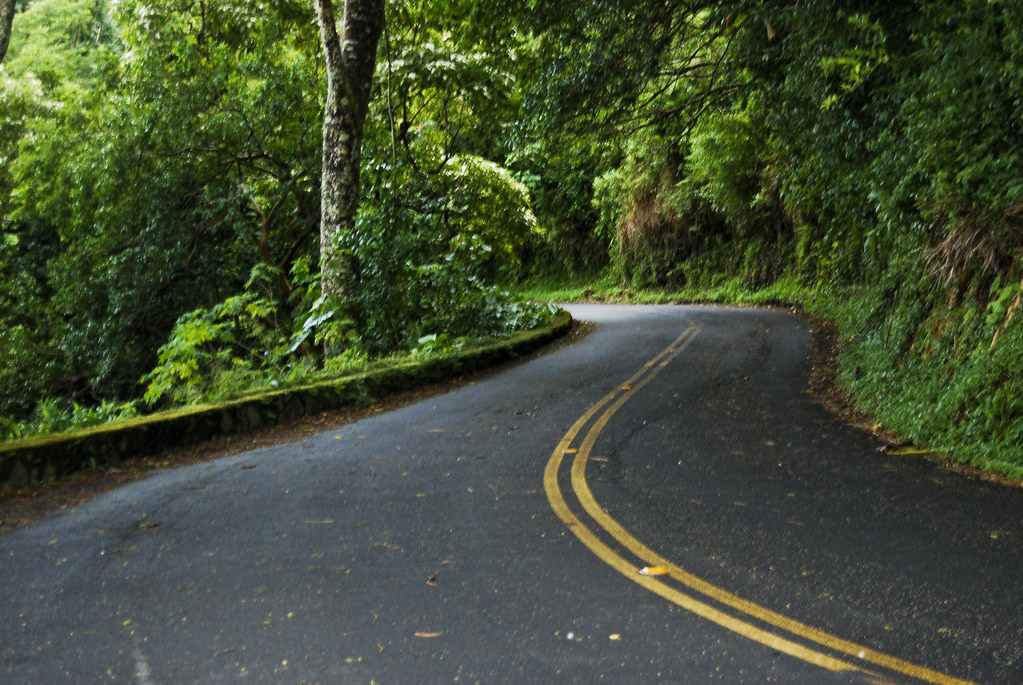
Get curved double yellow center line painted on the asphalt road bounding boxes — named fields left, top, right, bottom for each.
left=543, top=326, right=967, bottom=685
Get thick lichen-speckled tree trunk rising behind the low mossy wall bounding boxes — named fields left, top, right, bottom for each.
left=315, top=0, right=386, bottom=296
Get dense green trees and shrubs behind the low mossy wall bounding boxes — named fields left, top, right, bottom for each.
left=0, top=0, right=548, bottom=435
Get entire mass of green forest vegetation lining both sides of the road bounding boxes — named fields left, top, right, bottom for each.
left=0, top=0, right=1023, bottom=486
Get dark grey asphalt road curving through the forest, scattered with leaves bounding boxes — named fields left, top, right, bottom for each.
left=0, top=306, right=1023, bottom=685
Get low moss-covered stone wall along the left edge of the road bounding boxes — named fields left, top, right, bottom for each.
left=0, top=311, right=572, bottom=489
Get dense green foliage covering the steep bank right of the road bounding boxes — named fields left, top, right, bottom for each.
left=537, top=0, right=1023, bottom=476
